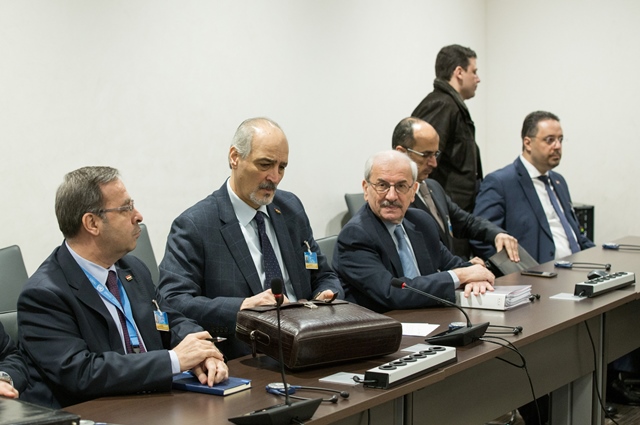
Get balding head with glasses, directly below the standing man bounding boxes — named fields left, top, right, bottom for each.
left=391, top=117, right=440, bottom=182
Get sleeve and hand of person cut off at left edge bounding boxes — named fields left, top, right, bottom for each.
left=0, top=323, right=28, bottom=398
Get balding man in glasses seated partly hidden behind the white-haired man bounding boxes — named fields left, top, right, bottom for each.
left=391, top=117, right=520, bottom=264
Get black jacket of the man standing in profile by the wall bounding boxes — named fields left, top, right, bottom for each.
left=411, top=78, right=482, bottom=212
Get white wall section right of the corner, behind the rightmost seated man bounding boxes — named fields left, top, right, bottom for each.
left=480, top=0, right=640, bottom=245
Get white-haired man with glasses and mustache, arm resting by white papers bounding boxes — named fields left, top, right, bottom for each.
left=333, top=150, right=494, bottom=313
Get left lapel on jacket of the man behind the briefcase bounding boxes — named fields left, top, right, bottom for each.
left=216, top=182, right=263, bottom=294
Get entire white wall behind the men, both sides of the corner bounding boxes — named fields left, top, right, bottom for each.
left=0, top=0, right=639, bottom=273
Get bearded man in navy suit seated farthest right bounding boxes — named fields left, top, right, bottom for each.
left=471, top=111, right=594, bottom=263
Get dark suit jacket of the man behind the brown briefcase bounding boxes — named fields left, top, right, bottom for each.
left=160, top=182, right=344, bottom=359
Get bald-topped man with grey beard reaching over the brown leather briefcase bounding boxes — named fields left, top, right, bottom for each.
left=160, top=118, right=343, bottom=359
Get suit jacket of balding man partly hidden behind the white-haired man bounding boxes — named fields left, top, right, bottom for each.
left=411, top=179, right=506, bottom=252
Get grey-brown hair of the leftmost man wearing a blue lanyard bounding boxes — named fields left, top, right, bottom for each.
left=55, top=167, right=120, bottom=238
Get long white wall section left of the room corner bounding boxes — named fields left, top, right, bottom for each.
left=0, top=0, right=485, bottom=274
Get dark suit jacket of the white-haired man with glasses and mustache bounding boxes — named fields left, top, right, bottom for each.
left=333, top=204, right=469, bottom=313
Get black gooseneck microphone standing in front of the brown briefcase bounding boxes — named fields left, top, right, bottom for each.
left=229, top=277, right=322, bottom=425
